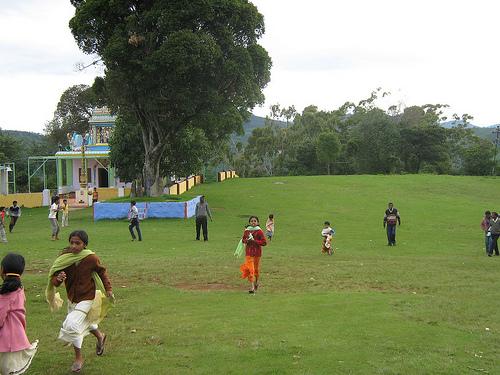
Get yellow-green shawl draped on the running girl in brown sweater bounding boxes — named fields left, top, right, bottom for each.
left=45, top=253, right=114, bottom=324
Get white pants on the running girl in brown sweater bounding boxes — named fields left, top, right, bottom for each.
left=58, top=301, right=97, bottom=349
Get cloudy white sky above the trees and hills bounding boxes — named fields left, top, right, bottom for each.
left=0, top=0, right=500, bottom=132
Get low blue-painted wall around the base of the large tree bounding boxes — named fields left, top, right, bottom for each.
left=94, top=196, right=200, bottom=221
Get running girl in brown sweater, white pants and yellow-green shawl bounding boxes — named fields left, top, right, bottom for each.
left=45, top=230, right=114, bottom=372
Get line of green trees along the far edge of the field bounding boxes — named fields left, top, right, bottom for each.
left=233, top=89, right=495, bottom=177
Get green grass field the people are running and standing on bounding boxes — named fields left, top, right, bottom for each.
left=0, top=175, right=500, bottom=375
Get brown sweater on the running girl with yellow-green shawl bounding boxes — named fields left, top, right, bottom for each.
left=52, top=254, right=112, bottom=303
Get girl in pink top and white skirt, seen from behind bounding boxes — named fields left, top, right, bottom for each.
left=0, top=254, right=38, bottom=375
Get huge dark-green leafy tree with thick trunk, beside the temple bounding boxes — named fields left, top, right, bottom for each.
left=70, top=0, right=271, bottom=195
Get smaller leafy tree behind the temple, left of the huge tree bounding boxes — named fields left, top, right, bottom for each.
left=45, top=85, right=98, bottom=146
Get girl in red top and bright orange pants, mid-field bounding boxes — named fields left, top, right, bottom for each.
left=240, top=216, right=267, bottom=294
